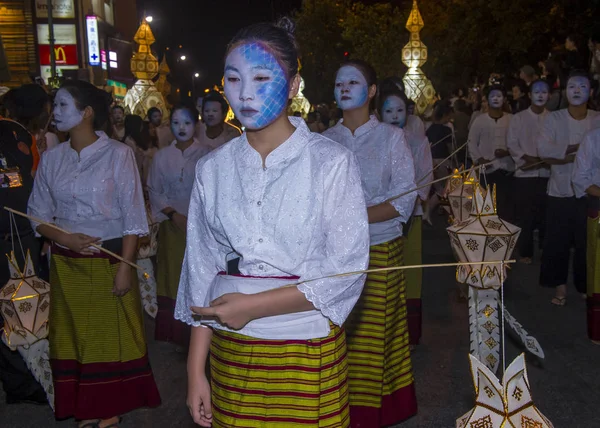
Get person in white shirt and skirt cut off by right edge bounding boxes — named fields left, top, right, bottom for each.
left=573, top=129, right=600, bottom=345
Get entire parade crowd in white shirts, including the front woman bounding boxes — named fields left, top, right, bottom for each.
left=0, top=19, right=600, bottom=428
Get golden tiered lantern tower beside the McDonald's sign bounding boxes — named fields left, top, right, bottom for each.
left=125, top=19, right=168, bottom=118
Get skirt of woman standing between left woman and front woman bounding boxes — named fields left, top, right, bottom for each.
left=154, top=220, right=190, bottom=347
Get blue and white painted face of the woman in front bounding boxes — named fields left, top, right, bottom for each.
left=224, top=43, right=289, bottom=129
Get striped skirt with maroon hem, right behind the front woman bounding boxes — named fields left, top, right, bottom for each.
left=346, top=238, right=417, bottom=428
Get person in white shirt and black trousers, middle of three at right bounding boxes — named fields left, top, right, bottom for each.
left=506, top=80, right=550, bottom=264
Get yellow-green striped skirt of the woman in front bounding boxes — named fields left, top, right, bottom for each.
left=210, top=326, right=350, bottom=428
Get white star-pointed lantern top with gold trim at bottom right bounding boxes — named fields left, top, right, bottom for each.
left=456, top=354, right=553, bottom=428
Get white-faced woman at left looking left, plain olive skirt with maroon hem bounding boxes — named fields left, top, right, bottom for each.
left=28, top=81, right=160, bottom=428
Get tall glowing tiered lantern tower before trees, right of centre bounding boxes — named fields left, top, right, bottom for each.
left=402, top=0, right=435, bottom=114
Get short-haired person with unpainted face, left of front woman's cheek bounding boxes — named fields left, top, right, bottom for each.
left=196, top=91, right=242, bottom=151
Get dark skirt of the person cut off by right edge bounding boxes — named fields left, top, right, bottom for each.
left=586, top=209, right=600, bottom=341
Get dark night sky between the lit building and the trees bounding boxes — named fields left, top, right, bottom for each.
left=138, top=0, right=302, bottom=94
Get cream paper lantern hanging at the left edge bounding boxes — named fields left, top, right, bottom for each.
left=0, top=251, right=50, bottom=351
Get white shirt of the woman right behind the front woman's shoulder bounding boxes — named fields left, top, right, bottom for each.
left=323, top=116, right=417, bottom=245
